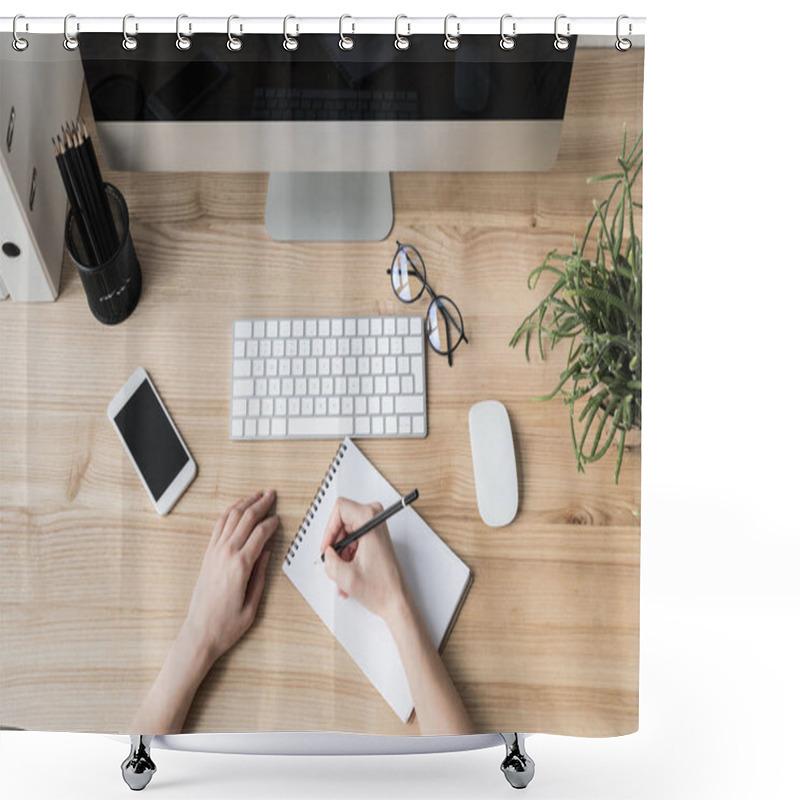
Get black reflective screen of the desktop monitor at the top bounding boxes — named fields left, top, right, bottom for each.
left=80, top=33, right=577, bottom=122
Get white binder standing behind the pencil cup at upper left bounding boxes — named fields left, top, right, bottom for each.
left=0, top=34, right=83, bottom=301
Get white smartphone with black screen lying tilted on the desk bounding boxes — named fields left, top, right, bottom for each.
left=108, top=367, right=197, bottom=515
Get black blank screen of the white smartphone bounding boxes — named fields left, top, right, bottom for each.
left=114, top=380, right=189, bottom=501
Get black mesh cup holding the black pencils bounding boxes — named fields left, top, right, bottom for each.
left=64, top=183, right=142, bottom=325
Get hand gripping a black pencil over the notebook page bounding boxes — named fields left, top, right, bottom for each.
left=320, top=497, right=407, bottom=621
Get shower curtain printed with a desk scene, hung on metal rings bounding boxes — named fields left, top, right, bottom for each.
left=0, top=18, right=644, bottom=736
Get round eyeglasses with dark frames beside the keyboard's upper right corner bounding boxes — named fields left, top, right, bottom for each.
left=386, top=242, right=469, bottom=367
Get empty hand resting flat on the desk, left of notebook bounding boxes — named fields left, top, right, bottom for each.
left=181, top=489, right=280, bottom=663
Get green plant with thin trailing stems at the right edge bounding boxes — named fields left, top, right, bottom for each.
left=510, top=129, right=642, bottom=483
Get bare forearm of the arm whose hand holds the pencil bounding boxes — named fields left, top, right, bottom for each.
left=387, top=598, right=473, bottom=736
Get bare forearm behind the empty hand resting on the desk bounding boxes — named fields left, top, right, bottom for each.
left=129, top=630, right=213, bottom=734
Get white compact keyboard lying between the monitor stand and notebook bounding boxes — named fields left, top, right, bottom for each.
left=231, top=316, right=428, bottom=439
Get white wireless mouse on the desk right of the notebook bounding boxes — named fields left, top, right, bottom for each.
left=469, top=400, right=519, bottom=528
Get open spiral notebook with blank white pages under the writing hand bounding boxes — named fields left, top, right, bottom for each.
left=283, top=439, right=471, bottom=722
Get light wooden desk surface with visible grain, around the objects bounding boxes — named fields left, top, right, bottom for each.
left=0, top=49, right=643, bottom=736
